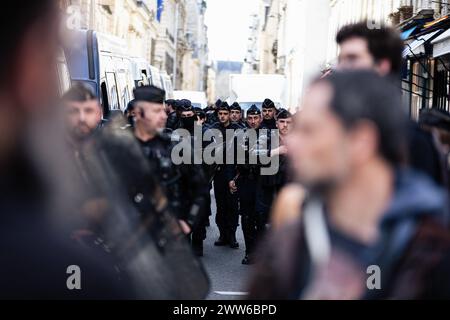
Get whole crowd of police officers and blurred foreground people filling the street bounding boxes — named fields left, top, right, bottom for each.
left=4, top=0, right=450, bottom=299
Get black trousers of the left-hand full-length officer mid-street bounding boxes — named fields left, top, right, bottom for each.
left=214, top=170, right=239, bottom=238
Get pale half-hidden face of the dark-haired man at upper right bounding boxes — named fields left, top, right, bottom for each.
left=338, top=37, right=375, bottom=70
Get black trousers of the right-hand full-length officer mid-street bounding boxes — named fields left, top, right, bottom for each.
left=237, top=176, right=265, bottom=254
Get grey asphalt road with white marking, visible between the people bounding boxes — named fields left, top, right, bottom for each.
left=202, top=188, right=252, bottom=300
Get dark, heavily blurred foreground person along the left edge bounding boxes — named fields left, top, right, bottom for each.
left=0, top=0, right=133, bottom=299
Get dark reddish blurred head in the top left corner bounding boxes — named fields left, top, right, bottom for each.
left=0, top=0, right=60, bottom=153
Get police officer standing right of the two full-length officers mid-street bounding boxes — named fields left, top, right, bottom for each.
left=236, top=105, right=262, bottom=265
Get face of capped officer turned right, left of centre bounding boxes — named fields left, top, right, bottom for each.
left=135, top=101, right=167, bottom=135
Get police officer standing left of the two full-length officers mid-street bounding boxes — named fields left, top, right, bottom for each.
left=210, top=102, right=240, bottom=249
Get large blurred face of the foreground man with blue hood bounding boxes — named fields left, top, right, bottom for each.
left=287, top=83, right=350, bottom=187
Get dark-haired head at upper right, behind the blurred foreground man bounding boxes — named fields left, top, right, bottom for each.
left=336, top=22, right=404, bottom=77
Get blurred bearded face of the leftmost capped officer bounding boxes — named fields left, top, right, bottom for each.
left=66, top=100, right=102, bottom=140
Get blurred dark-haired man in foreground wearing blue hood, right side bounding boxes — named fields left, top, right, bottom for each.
left=250, top=71, right=450, bottom=299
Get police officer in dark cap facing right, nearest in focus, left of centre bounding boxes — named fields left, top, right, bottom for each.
left=134, top=86, right=206, bottom=233
